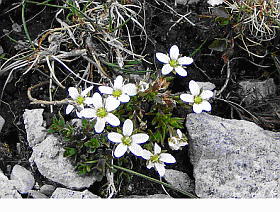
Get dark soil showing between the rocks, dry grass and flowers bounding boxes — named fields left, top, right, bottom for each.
left=0, top=0, right=280, bottom=198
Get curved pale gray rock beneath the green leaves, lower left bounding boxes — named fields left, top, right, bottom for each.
left=29, top=134, right=96, bottom=189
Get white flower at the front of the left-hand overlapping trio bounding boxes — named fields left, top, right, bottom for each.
left=77, top=92, right=120, bottom=133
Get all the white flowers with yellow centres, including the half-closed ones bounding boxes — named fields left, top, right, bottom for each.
left=66, top=45, right=213, bottom=177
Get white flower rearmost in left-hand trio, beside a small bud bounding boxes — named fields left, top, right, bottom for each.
left=98, top=75, right=137, bottom=103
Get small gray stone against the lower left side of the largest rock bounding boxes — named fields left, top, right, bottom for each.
left=164, top=169, right=194, bottom=193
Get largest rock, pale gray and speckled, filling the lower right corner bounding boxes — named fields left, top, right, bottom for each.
left=186, top=113, right=280, bottom=198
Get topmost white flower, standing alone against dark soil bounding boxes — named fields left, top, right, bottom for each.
left=156, top=45, right=193, bottom=77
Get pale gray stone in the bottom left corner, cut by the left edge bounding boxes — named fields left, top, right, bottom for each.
left=0, top=180, right=22, bottom=199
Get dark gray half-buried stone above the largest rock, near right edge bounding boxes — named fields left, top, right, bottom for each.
left=238, top=78, right=276, bottom=105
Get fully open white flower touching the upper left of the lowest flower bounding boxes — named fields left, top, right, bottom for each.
left=108, top=119, right=149, bottom=158
